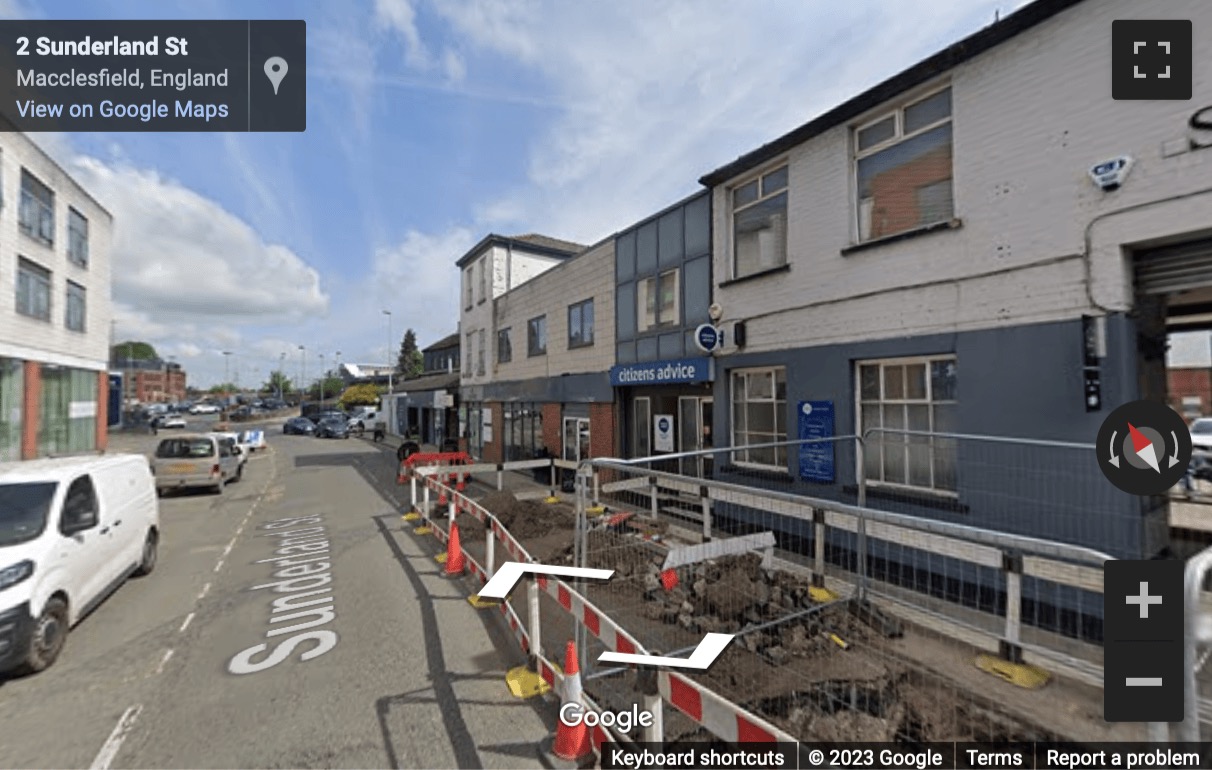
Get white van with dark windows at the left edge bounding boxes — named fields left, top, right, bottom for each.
left=0, top=455, right=160, bottom=672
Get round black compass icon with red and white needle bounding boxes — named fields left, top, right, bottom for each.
left=1096, top=400, right=1191, bottom=495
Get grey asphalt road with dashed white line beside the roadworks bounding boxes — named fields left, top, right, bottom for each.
left=0, top=421, right=556, bottom=768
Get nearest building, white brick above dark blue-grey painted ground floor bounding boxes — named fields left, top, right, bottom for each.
left=703, top=0, right=1212, bottom=558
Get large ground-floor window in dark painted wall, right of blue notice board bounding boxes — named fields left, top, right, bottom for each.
left=858, top=355, right=956, bottom=494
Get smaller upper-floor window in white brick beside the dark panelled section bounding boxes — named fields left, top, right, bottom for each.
left=732, top=166, right=788, bottom=278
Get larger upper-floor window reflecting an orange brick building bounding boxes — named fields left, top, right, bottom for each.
left=854, top=89, right=955, bottom=240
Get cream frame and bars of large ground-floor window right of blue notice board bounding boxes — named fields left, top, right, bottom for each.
left=853, top=353, right=960, bottom=500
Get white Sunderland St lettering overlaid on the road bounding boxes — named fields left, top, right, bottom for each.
left=228, top=517, right=338, bottom=674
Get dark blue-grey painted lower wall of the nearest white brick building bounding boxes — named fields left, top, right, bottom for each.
left=714, top=315, right=1166, bottom=559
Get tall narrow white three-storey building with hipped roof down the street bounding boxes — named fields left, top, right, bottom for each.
left=457, top=234, right=584, bottom=456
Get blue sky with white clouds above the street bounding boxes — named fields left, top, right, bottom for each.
left=7, top=0, right=1042, bottom=386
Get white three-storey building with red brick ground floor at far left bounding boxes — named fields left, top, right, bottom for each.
left=0, top=132, right=113, bottom=461
